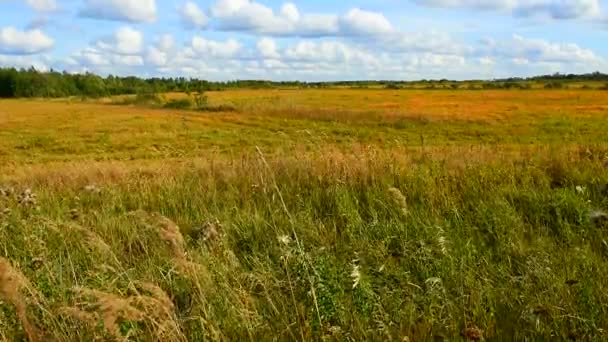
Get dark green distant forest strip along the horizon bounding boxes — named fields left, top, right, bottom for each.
left=0, top=68, right=608, bottom=98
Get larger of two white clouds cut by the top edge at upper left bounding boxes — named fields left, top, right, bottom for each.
left=80, top=0, right=156, bottom=22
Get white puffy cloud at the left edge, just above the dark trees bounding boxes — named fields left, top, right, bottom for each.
left=0, top=26, right=55, bottom=55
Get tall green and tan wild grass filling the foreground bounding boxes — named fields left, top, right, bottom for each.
left=0, top=147, right=608, bottom=341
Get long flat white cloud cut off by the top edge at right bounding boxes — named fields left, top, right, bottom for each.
left=412, top=0, right=602, bottom=19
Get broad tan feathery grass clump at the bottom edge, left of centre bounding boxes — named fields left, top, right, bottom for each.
left=60, top=283, right=184, bottom=340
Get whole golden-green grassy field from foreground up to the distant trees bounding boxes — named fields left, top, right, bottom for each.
left=0, top=89, right=608, bottom=341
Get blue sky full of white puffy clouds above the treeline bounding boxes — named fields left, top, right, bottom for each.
left=0, top=0, right=608, bottom=81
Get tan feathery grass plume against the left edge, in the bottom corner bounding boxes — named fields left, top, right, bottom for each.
left=0, top=257, right=38, bottom=341
